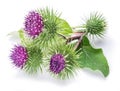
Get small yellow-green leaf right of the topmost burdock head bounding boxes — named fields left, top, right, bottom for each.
left=57, top=19, right=73, bottom=37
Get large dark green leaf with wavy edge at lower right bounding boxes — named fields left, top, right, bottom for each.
left=79, top=37, right=109, bottom=77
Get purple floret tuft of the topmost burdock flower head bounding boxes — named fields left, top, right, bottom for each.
left=24, top=11, right=44, bottom=38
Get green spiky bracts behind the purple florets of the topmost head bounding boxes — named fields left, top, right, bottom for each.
left=34, top=8, right=59, bottom=49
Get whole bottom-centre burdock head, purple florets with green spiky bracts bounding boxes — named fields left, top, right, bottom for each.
left=47, top=38, right=78, bottom=79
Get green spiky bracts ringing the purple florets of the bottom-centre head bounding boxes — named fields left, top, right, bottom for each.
left=47, top=39, right=78, bottom=79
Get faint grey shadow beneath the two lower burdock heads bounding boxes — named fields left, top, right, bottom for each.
left=15, top=71, right=75, bottom=86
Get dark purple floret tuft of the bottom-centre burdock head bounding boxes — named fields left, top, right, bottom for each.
left=50, top=54, right=65, bottom=74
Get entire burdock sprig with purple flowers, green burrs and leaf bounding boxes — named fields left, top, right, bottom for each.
left=10, top=8, right=109, bottom=79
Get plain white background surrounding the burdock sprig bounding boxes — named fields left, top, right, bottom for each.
left=0, top=0, right=120, bottom=91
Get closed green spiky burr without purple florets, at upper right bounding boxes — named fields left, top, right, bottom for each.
left=85, top=13, right=106, bottom=37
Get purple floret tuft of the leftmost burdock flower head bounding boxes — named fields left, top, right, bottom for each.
left=10, top=46, right=28, bottom=68
